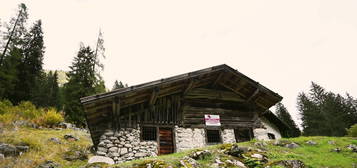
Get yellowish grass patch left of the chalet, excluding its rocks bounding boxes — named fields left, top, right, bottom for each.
left=0, top=128, right=92, bottom=168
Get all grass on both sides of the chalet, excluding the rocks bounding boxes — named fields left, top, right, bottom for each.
left=0, top=128, right=357, bottom=168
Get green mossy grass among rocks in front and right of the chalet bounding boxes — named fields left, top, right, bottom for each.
left=116, top=137, right=357, bottom=168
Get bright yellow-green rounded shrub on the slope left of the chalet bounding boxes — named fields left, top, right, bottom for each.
left=38, top=108, right=64, bottom=127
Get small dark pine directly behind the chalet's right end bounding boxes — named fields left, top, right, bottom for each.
left=275, top=103, right=300, bottom=137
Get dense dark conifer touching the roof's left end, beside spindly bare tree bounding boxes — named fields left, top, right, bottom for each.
left=64, top=45, right=105, bottom=126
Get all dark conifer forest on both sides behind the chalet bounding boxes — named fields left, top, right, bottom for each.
left=0, top=4, right=357, bottom=137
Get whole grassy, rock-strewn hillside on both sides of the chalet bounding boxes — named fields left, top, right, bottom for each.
left=0, top=128, right=357, bottom=168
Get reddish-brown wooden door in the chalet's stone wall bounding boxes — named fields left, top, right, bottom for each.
left=159, top=128, right=174, bottom=155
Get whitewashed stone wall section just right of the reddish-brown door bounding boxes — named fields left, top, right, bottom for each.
left=174, top=126, right=206, bottom=152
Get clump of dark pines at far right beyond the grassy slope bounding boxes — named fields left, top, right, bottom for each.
left=298, top=83, right=356, bottom=136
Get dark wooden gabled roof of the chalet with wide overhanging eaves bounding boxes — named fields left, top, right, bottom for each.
left=81, top=64, right=282, bottom=111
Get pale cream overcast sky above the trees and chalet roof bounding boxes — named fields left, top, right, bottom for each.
left=0, top=0, right=357, bottom=126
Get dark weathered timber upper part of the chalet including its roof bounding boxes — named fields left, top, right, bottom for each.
left=81, top=64, right=286, bottom=158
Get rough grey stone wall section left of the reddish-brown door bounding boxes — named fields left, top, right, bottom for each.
left=96, top=128, right=158, bottom=163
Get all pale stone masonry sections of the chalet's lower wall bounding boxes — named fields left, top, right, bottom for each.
left=96, top=120, right=280, bottom=163
